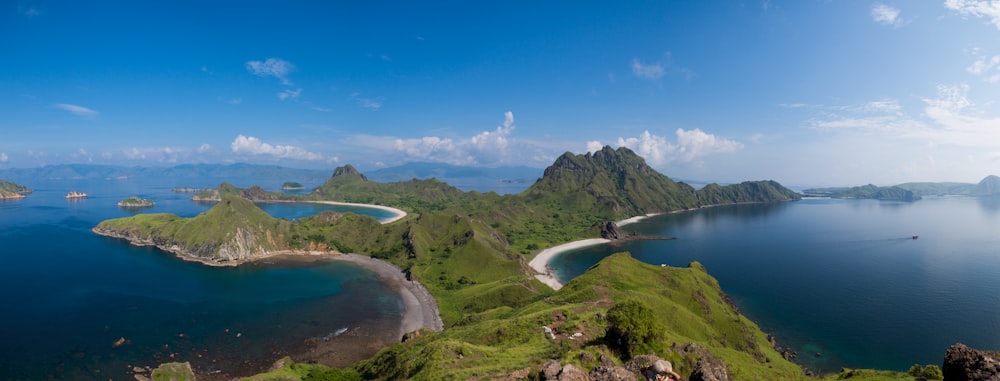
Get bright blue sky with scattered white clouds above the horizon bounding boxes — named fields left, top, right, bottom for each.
left=0, top=0, right=1000, bottom=185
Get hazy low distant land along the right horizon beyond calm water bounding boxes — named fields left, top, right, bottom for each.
left=802, top=175, right=1000, bottom=202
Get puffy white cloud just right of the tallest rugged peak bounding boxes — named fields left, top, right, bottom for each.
left=600, top=128, right=743, bottom=166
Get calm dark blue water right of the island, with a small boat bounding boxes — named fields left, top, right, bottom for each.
left=552, top=198, right=1000, bottom=371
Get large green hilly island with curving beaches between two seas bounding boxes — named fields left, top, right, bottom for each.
left=93, top=147, right=976, bottom=380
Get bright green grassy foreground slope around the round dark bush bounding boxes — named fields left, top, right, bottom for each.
left=354, top=254, right=806, bottom=380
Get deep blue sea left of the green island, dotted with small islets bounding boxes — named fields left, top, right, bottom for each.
left=0, top=179, right=401, bottom=380
